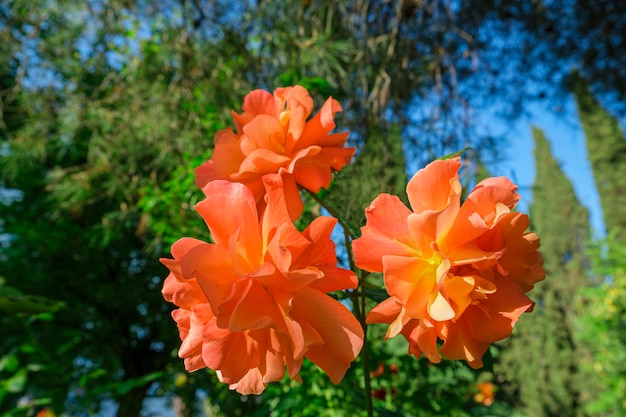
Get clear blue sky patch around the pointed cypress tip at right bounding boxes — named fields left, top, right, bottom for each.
left=492, top=95, right=605, bottom=238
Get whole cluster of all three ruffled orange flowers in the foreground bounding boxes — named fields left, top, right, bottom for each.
left=161, top=86, right=545, bottom=395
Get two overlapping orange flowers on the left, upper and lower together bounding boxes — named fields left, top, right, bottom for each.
left=161, top=87, right=363, bottom=394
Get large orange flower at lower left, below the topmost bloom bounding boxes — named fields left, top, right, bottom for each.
left=161, top=174, right=363, bottom=394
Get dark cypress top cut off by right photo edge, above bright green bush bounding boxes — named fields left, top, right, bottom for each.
left=572, top=74, right=626, bottom=240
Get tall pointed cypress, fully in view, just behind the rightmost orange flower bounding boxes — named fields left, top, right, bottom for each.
left=501, top=127, right=590, bottom=417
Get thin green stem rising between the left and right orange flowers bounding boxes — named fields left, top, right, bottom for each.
left=307, top=190, right=374, bottom=417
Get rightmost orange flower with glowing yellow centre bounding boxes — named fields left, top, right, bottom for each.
left=353, top=158, right=545, bottom=368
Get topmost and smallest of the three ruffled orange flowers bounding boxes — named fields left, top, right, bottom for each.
left=195, top=86, right=355, bottom=220
